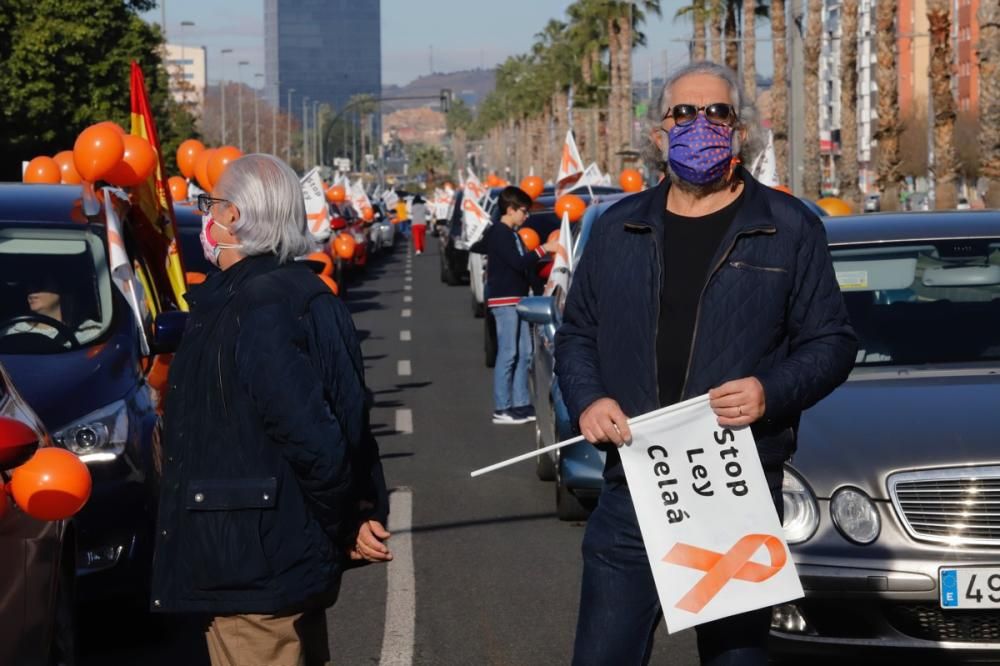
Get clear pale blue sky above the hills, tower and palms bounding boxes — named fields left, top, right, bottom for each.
left=144, top=0, right=771, bottom=84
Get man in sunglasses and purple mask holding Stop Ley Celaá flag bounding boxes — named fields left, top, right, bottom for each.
left=555, top=63, right=857, bottom=666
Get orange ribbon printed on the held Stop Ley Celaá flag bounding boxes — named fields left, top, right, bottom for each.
left=663, top=534, right=787, bottom=613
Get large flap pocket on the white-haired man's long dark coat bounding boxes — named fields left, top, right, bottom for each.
left=184, top=477, right=278, bottom=591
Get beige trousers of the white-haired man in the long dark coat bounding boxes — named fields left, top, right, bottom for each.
left=205, top=609, right=331, bottom=666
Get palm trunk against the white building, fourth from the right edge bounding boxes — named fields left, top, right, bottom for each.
left=837, top=0, right=861, bottom=212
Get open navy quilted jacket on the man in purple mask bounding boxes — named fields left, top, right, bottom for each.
left=555, top=169, right=857, bottom=480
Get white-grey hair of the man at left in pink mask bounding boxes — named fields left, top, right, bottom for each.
left=215, top=153, right=315, bottom=263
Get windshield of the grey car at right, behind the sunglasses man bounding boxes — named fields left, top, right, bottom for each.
left=832, top=239, right=1000, bottom=367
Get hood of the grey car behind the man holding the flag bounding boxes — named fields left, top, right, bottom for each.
left=792, top=366, right=1000, bottom=499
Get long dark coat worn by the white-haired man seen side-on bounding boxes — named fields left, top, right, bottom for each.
left=151, top=256, right=388, bottom=614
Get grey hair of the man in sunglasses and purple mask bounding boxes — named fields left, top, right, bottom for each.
left=643, top=60, right=764, bottom=171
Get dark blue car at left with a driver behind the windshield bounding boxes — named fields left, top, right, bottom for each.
left=0, top=184, right=184, bottom=600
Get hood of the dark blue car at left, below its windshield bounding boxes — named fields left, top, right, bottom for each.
left=0, top=332, right=141, bottom=434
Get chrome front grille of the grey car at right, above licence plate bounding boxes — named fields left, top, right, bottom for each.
left=889, top=466, right=1000, bottom=545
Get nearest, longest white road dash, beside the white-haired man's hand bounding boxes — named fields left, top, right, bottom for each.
left=379, top=488, right=417, bottom=666
